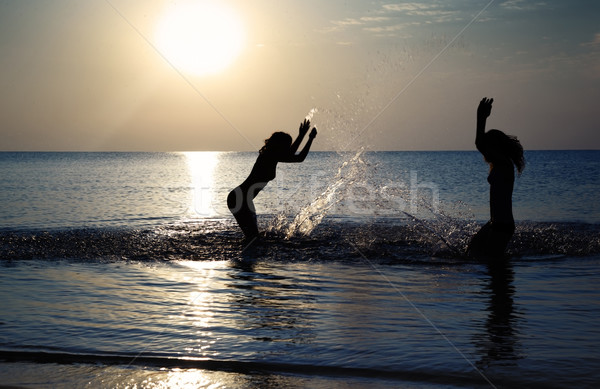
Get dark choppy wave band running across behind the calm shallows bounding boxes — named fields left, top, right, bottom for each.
left=0, top=218, right=600, bottom=263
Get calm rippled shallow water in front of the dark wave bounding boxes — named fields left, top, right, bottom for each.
left=0, top=256, right=600, bottom=387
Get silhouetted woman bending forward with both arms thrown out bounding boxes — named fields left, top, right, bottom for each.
left=227, top=119, right=317, bottom=240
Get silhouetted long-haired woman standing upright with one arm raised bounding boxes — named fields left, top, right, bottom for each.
left=468, top=97, right=525, bottom=257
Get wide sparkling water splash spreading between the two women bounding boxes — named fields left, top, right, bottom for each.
left=280, top=147, right=476, bottom=250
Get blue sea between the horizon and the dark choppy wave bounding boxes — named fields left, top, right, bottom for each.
left=0, top=151, right=600, bottom=229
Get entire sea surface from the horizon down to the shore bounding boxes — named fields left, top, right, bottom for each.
left=0, top=150, right=600, bottom=388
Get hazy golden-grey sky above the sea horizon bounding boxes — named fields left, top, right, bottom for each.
left=0, top=0, right=600, bottom=151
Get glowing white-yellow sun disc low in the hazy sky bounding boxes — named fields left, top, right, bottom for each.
left=155, top=0, right=245, bottom=76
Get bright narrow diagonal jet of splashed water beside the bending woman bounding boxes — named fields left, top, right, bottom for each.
left=285, top=147, right=365, bottom=239
